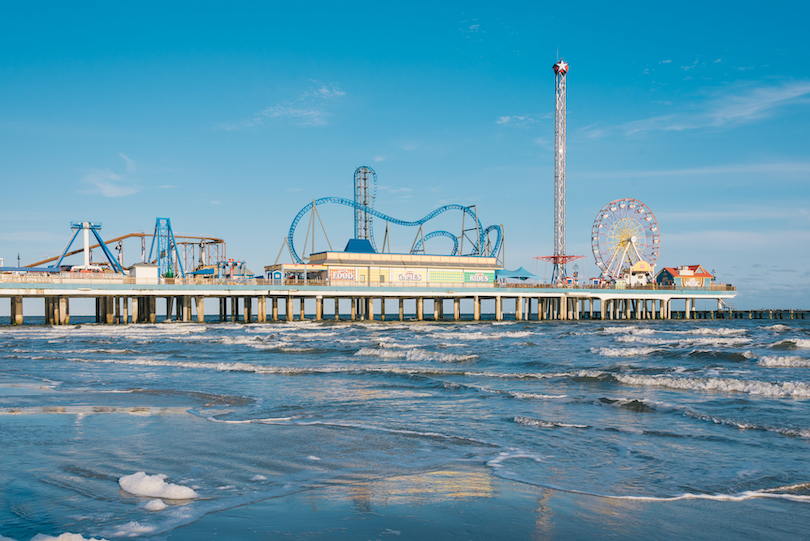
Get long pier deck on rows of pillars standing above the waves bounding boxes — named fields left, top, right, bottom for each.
left=0, top=275, right=752, bottom=325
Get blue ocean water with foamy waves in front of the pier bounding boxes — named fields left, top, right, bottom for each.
left=0, top=320, right=810, bottom=541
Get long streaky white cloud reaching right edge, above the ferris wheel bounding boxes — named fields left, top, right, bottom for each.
left=616, top=81, right=810, bottom=137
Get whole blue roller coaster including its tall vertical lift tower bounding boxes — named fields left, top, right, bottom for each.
left=287, top=166, right=503, bottom=264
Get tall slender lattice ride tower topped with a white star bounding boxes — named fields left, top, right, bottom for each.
left=540, top=59, right=584, bottom=284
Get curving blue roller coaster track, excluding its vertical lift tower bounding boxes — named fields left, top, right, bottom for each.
left=287, top=197, right=503, bottom=264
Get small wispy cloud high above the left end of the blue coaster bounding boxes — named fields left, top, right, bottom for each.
left=217, top=81, right=346, bottom=131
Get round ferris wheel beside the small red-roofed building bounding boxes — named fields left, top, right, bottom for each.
left=591, top=198, right=661, bottom=280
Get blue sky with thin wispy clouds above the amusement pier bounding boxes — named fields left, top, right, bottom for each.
left=0, top=2, right=810, bottom=308
